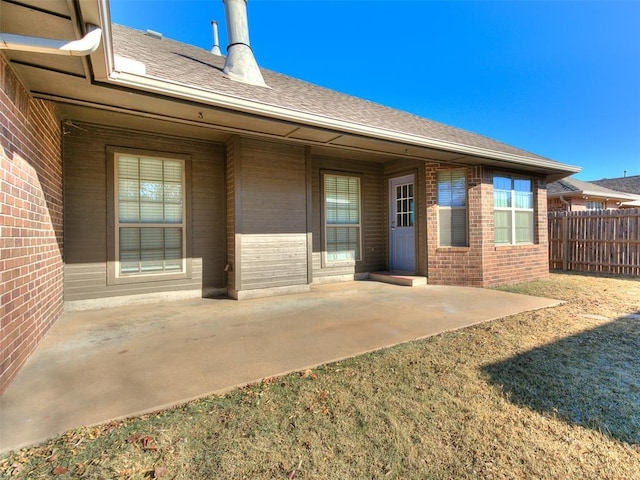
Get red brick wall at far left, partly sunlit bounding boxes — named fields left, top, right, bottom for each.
left=0, top=55, right=63, bottom=393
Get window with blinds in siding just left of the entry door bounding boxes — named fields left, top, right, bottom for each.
left=324, top=174, right=361, bottom=263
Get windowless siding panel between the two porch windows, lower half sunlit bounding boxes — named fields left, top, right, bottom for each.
left=234, top=139, right=307, bottom=291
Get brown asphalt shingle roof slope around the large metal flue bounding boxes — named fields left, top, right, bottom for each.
left=112, top=24, right=550, bottom=161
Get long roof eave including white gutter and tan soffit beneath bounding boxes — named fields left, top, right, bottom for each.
left=1, top=0, right=579, bottom=181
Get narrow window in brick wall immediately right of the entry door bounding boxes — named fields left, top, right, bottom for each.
left=438, top=170, right=468, bottom=247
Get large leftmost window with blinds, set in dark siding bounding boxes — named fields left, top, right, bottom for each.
left=114, top=153, right=186, bottom=278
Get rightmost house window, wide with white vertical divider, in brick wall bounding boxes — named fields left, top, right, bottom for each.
left=493, top=175, right=535, bottom=245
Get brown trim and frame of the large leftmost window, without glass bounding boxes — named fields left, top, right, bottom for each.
left=107, top=146, right=193, bottom=285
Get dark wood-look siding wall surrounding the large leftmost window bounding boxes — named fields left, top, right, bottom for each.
left=63, top=124, right=225, bottom=301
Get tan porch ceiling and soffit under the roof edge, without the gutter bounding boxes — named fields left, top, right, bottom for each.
left=0, top=0, right=567, bottom=180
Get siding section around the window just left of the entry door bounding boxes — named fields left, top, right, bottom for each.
left=311, top=156, right=386, bottom=282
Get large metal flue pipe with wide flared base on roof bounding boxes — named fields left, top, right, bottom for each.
left=222, top=0, right=267, bottom=87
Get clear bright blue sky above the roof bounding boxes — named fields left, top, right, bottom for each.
left=110, top=0, right=640, bottom=180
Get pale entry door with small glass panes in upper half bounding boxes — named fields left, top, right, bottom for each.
left=389, top=175, right=416, bottom=272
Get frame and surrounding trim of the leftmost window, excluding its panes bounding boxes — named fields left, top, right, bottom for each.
left=108, top=147, right=192, bottom=285
